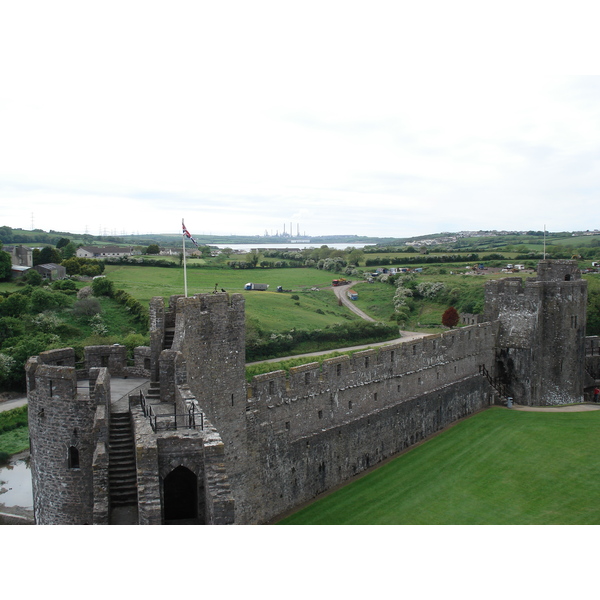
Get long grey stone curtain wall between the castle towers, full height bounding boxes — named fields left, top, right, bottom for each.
left=238, top=323, right=495, bottom=522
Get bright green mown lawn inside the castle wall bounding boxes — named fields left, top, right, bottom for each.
left=281, top=408, right=600, bottom=525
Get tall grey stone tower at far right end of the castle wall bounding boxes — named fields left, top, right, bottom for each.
left=485, top=260, right=587, bottom=406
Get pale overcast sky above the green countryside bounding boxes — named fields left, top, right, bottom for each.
left=0, top=0, right=600, bottom=237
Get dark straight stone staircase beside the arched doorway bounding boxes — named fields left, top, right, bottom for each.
left=108, top=412, right=137, bottom=509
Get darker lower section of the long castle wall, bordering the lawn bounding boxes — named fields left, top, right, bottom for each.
left=242, top=375, right=494, bottom=523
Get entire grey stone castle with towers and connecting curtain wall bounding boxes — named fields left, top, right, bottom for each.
left=26, top=261, right=600, bottom=525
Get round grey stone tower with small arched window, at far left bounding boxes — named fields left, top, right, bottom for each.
left=25, top=349, right=96, bottom=525
